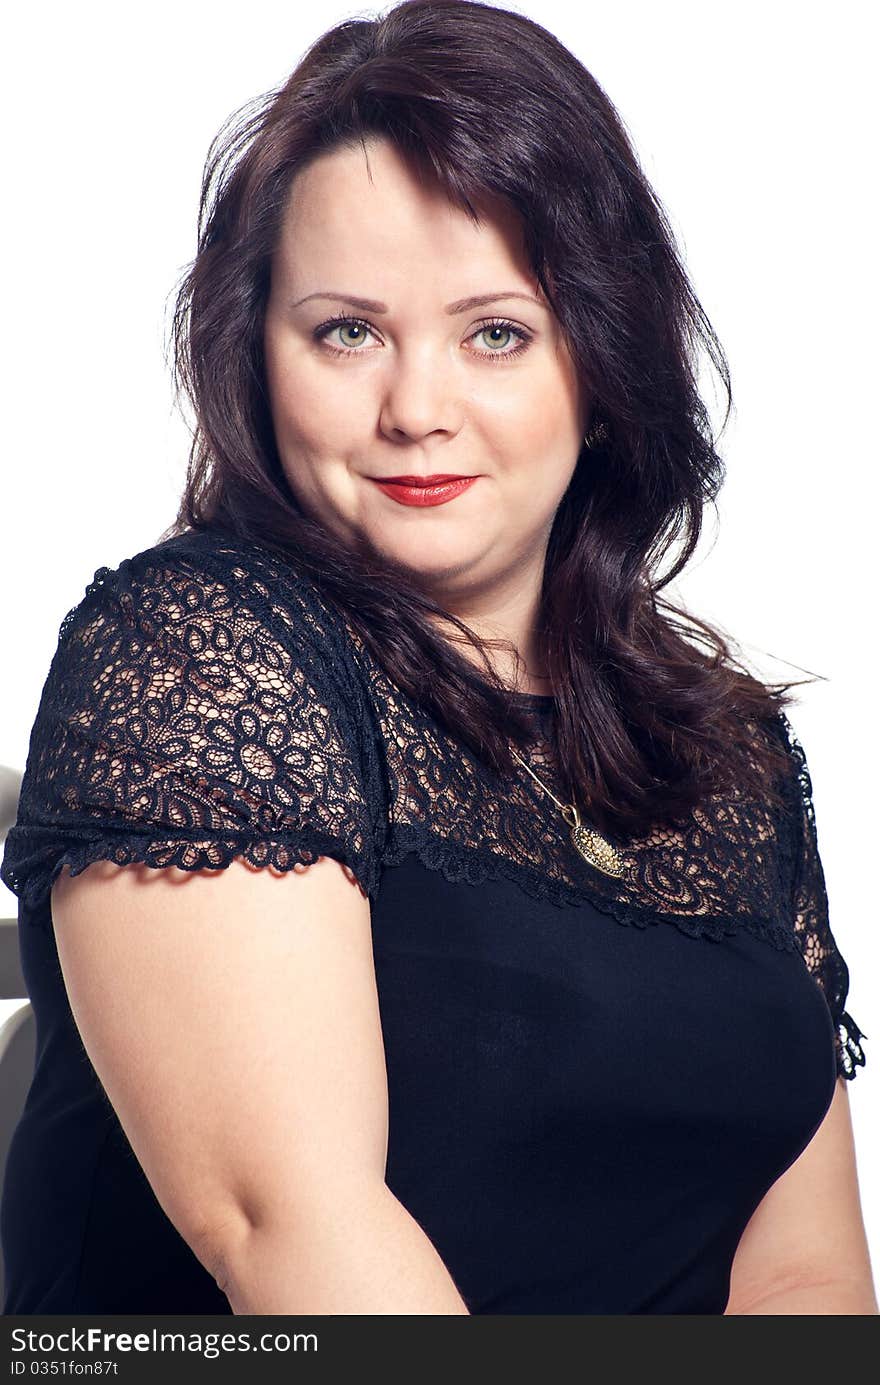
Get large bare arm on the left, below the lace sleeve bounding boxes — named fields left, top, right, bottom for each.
left=51, top=857, right=467, bottom=1314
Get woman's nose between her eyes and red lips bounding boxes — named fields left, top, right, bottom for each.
left=380, top=341, right=464, bottom=442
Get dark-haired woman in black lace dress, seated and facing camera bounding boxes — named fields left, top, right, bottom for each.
left=3, top=0, right=877, bottom=1314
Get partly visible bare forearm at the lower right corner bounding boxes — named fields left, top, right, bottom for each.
left=726, top=1078, right=877, bottom=1316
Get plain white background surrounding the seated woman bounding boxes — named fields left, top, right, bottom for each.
left=0, top=0, right=880, bottom=1276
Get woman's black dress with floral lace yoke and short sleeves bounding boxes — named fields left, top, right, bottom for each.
left=0, top=533, right=865, bottom=1314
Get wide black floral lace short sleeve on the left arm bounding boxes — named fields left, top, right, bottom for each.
left=0, top=547, right=381, bottom=925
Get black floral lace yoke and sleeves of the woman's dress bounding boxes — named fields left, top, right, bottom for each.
left=0, top=533, right=865, bottom=1078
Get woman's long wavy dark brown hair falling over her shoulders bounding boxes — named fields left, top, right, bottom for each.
left=162, top=0, right=804, bottom=837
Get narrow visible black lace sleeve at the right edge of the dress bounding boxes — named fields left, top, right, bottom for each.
left=780, top=713, right=868, bottom=1079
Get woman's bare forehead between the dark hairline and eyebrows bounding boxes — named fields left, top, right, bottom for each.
left=273, top=140, right=536, bottom=298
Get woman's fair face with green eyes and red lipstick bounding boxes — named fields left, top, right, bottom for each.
left=265, top=140, right=586, bottom=596
